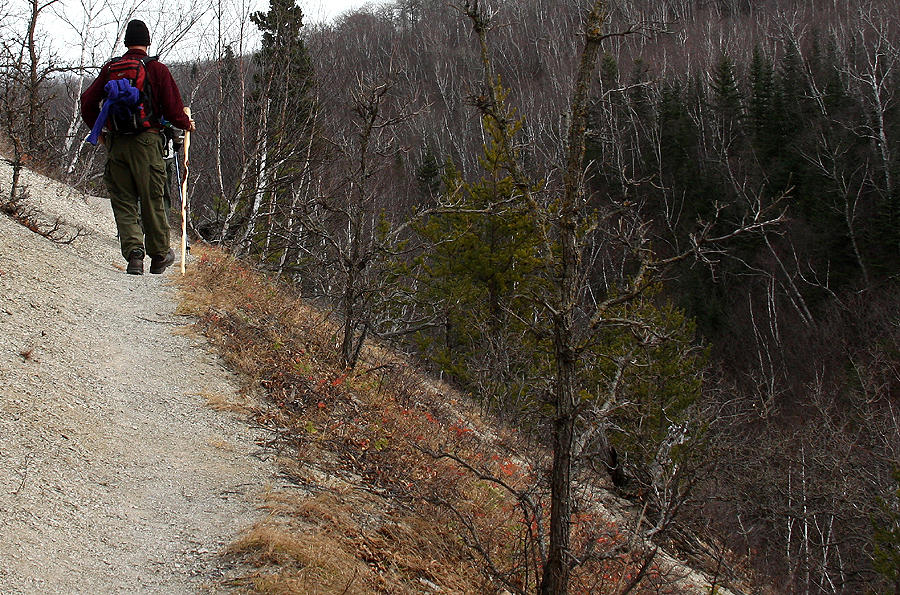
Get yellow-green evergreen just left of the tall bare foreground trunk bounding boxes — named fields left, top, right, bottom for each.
left=417, top=96, right=540, bottom=413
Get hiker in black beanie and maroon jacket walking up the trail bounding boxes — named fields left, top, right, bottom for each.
left=81, top=20, right=195, bottom=275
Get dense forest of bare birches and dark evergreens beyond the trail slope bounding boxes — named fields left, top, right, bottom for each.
left=0, top=0, right=900, bottom=593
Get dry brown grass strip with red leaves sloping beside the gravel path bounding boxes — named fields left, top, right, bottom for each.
left=179, top=246, right=716, bottom=593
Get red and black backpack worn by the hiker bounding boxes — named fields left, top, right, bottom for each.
left=106, top=56, right=159, bottom=134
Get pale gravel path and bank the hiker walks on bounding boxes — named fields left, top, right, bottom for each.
left=0, top=165, right=274, bottom=594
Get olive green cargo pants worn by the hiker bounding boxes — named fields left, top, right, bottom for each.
left=103, top=132, right=169, bottom=259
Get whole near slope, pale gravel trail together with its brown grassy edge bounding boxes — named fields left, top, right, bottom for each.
left=0, top=158, right=737, bottom=594
